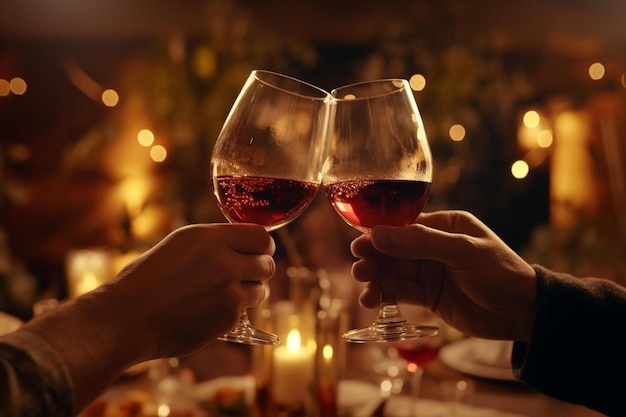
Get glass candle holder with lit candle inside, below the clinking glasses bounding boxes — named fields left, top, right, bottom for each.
left=253, top=267, right=347, bottom=417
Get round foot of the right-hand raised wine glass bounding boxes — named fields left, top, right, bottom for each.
left=343, top=322, right=439, bottom=343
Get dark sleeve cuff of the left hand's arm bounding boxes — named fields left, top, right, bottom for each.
left=0, top=330, right=74, bottom=417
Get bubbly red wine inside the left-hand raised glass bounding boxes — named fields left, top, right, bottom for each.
left=214, top=175, right=319, bottom=230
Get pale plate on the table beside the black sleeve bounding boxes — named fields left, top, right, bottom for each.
left=439, top=338, right=517, bottom=381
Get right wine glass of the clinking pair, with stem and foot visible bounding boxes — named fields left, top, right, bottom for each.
left=323, top=79, right=438, bottom=343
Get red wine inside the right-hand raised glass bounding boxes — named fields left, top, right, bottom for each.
left=324, top=180, right=430, bottom=229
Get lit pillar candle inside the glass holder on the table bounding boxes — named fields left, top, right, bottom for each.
left=272, top=329, right=315, bottom=409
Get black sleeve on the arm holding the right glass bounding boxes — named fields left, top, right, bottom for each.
left=512, top=266, right=626, bottom=416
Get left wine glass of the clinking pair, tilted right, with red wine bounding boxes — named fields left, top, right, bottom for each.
left=211, top=70, right=332, bottom=345
